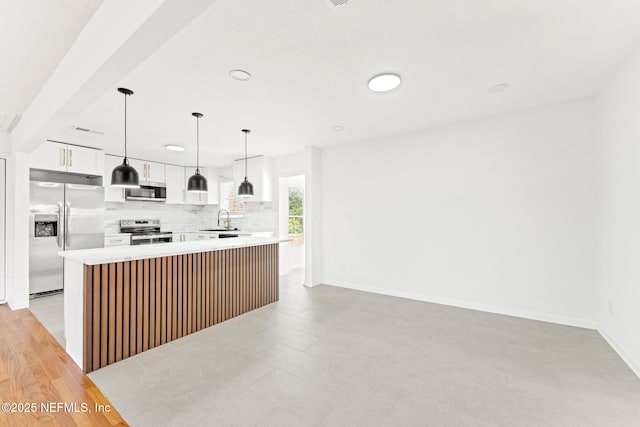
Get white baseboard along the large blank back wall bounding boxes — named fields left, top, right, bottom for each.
left=322, top=280, right=597, bottom=330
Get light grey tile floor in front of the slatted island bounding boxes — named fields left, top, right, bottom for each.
left=36, top=273, right=640, bottom=427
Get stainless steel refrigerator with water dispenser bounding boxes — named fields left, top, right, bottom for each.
left=29, top=181, right=104, bottom=295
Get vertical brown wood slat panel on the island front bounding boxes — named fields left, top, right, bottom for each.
left=83, top=244, right=279, bottom=372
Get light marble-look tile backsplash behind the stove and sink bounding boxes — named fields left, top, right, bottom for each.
left=104, top=200, right=278, bottom=234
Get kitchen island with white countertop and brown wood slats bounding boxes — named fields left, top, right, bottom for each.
left=59, top=237, right=286, bottom=372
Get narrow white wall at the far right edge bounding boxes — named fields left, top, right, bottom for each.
left=598, top=44, right=640, bottom=375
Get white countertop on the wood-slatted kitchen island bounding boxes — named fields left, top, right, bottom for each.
left=58, top=237, right=289, bottom=265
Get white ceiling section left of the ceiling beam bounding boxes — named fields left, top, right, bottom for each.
left=0, top=0, right=102, bottom=115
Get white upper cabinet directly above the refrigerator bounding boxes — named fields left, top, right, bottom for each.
left=29, top=141, right=104, bottom=176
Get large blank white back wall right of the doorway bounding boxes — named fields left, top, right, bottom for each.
left=319, top=101, right=596, bottom=327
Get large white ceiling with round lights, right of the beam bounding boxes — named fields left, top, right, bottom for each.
left=51, top=0, right=640, bottom=165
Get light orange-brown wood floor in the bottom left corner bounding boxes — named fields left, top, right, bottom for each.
left=0, top=305, right=128, bottom=426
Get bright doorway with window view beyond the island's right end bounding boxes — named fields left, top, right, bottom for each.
left=278, top=175, right=305, bottom=283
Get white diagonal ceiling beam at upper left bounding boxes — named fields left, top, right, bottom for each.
left=12, top=0, right=217, bottom=152
